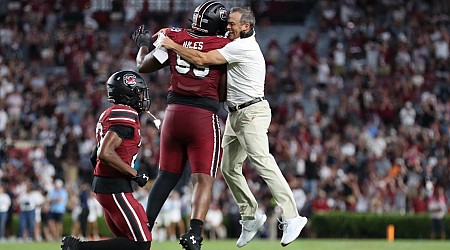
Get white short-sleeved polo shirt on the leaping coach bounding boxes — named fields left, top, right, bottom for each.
left=218, top=34, right=266, bottom=107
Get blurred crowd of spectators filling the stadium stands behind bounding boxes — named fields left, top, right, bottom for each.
left=0, top=0, right=450, bottom=240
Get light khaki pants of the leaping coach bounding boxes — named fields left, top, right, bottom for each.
left=221, top=100, right=298, bottom=220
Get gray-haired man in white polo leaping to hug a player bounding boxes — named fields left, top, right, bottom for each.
left=161, top=7, right=307, bottom=247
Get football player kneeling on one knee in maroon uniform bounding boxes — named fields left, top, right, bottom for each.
left=61, top=71, right=152, bottom=250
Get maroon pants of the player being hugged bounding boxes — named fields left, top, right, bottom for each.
left=160, top=104, right=222, bottom=177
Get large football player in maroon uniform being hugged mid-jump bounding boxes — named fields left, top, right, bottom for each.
left=132, top=1, right=230, bottom=249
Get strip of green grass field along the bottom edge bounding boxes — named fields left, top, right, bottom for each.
left=0, top=239, right=450, bottom=250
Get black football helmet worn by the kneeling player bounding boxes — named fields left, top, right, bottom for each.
left=106, top=70, right=151, bottom=113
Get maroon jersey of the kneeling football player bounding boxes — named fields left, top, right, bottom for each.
left=94, top=104, right=141, bottom=178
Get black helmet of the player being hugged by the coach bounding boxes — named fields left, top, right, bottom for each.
left=192, top=1, right=228, bottom=36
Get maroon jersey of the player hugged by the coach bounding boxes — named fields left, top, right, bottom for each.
left=166, top=28, right=230, bottom=100
